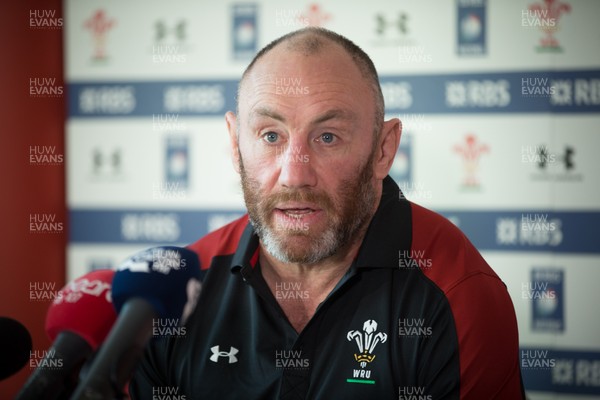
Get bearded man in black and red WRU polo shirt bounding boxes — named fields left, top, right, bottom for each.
left=130, top=28, right=522, bottom=400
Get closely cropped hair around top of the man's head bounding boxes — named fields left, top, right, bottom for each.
left=237, top=27, right=384, bottom=134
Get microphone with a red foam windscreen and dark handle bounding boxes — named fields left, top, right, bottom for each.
left=16, top=270, right=117, bottom=400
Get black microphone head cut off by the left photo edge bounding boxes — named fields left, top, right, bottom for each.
left=0, top=317, right=32, bottom=380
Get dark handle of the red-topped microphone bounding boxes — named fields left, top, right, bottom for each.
left=15, top=331, right=92, bottom=400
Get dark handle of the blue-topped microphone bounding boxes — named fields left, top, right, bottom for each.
left=71, top=297, right=157, bottom=400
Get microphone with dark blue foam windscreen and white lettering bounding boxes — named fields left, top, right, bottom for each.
left=71, top=246, right=200, bottom=400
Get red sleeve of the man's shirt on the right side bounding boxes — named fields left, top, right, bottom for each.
left=411, top=204, right=522, bottom=400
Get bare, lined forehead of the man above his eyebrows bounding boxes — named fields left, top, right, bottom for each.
left=237, top=40, right=372, bottom=122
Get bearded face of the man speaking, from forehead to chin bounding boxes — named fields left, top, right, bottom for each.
left=237, top=46, right=377, bottom=264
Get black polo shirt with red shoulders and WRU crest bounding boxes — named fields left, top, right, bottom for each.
left=130, top=177, right=522, bottom=400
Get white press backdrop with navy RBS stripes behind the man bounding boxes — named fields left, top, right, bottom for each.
left=65, top=0, right=600, bottom=399
